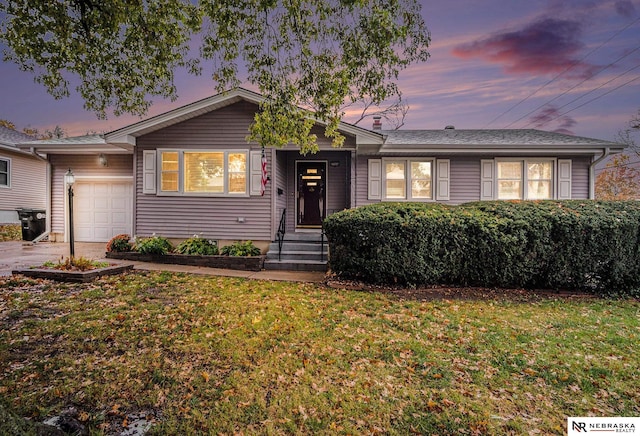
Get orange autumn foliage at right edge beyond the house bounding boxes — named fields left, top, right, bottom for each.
left=596, top=154, right=640, bottom=200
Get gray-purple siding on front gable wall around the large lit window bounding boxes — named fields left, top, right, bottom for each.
left=134, top=102, right=277, bottom=241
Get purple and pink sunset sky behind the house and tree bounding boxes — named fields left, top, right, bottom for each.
left=0, top=0, right=640, bottom=140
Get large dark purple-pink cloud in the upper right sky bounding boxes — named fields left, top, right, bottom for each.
left=453, top=18, right=592, bottom=76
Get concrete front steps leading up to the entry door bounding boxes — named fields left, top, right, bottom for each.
left=264, top=233, right=329, bottom=271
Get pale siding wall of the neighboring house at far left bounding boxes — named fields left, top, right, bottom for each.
left=0, top=151, right=47, bottom=219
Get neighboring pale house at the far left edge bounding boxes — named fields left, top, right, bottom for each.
left=0, top=126, right=48, bottom=224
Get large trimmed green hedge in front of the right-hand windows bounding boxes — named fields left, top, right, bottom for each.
left=324, top=200, right=640, bottom=295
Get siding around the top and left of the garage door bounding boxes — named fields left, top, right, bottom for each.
left=49, top=154, right=133, bottom=233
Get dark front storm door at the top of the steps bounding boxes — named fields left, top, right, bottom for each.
left=296, top=161, right=327, bottom=228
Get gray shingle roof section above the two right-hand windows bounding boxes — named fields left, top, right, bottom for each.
left=382, top=129, right=620, bottom=148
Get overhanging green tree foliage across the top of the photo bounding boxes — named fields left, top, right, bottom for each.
left=0, top=0, right=430, bottom=152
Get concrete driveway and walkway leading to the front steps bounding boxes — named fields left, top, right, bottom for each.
left=0, top=241, right=325, bottom=283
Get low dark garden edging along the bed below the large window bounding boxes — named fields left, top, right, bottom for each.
left=105, top=251, right=265, bottom=271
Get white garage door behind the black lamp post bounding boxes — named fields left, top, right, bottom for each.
left=73, top=181, right=133, bottom=242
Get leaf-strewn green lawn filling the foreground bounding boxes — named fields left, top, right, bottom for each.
left=0, top=273, right=640, bottom=435
